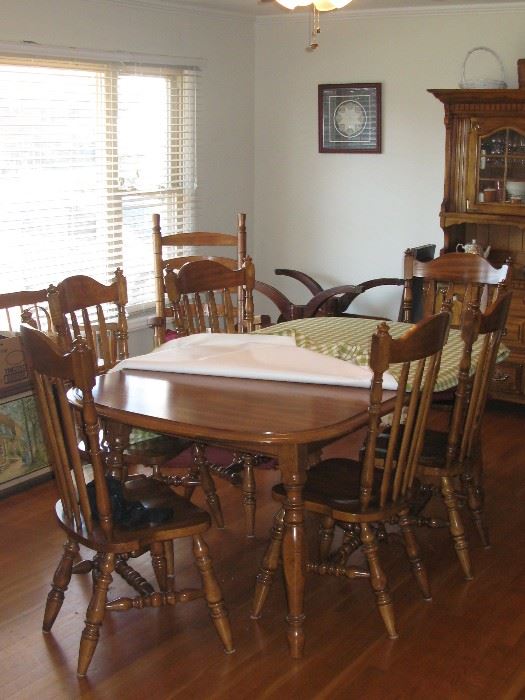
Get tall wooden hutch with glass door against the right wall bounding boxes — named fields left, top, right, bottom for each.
left=429, top=89, right=525, bottom=403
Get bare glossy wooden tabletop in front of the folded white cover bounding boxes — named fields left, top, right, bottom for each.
left=93, top=360, right=393, bottom=453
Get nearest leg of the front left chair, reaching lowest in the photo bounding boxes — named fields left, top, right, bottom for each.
left=77, top=554, right=115, bottom=677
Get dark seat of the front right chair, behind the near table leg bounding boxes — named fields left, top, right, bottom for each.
left=272, top=457, right=382, bottom=513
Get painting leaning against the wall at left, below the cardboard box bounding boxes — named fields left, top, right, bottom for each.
left=0, top=392, right=50, bottom=496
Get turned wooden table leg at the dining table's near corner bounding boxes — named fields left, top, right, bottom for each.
left=279, top=445, right=307, bottom=659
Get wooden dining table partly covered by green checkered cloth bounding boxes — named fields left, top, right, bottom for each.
left=84, top=317, right=506, bottom=658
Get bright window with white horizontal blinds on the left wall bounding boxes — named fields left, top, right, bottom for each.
left=0, top=57, right=198, bottom=313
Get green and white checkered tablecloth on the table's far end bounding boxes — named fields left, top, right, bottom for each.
left=255, top=316, right=509, bottom=391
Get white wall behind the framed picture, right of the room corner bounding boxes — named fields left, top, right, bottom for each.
left=254, top=2, right=525, bottom=313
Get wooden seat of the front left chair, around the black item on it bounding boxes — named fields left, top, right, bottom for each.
left=55, top=475, right=211, bottom=552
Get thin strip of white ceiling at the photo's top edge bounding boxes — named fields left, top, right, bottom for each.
left=171, top=0, right=508, bottom=17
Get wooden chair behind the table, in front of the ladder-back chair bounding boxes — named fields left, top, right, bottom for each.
left=164, top=257, right=257, bottom=537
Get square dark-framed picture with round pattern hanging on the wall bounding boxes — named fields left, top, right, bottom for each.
left=318, top=83, right=381, bottom=153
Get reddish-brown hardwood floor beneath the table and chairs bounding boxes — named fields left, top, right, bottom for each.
left=0, top=405, right=525, bottom=700
